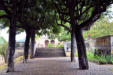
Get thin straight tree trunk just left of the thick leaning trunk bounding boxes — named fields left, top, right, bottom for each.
left=71, top=28, right=75, bottom=62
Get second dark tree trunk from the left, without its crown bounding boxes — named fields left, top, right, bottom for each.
left=24, top=30, right=30, bottom=63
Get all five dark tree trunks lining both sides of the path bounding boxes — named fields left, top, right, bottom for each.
left=8, top=18, right=88, bottom=72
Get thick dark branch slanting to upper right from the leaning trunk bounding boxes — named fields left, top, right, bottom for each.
left=79, top=1, right=111, bottom=29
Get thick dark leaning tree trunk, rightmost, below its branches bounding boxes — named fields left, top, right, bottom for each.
left=75, top=29, right=89, bottom=69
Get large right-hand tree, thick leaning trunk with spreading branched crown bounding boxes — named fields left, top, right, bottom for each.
left=52, top=0, right=112, bottom=69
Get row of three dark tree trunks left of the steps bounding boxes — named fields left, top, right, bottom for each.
left=7, top=25, right=35, bottom=72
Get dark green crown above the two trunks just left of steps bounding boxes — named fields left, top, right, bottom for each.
left=18, top=0, right=60, bottom=39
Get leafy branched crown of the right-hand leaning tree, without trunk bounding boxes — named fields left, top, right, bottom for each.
left=52, top=0, right=112, bottom=29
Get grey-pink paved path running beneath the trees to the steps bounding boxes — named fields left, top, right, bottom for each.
left=0, top=57, right=113, bottom=75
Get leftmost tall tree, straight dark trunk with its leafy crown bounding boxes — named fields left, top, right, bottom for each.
left=0, top=0, right=35, bottom=72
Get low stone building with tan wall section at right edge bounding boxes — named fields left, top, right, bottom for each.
left=86, top=35, right=113, bottom=54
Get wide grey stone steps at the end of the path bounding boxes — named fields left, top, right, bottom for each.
left=35, top=48, right=65, bottom=57
